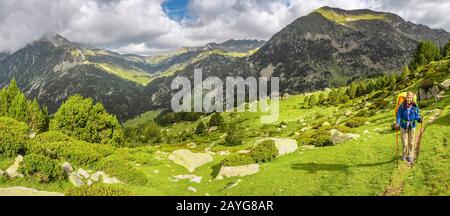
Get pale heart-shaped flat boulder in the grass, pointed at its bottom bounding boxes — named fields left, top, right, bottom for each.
left=169, top=149, right=213, bottom=172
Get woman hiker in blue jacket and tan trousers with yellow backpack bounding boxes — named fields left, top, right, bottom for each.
left=396, top=92, right=422, bottom=165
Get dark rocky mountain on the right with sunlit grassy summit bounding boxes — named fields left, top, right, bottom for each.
left=146, top=7, right=450, bottom=107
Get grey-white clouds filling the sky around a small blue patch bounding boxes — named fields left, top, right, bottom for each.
left=0, top=0, right=450, bottom=54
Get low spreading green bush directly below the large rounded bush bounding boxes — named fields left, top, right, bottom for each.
left=26, top=140, right=115, bottom=165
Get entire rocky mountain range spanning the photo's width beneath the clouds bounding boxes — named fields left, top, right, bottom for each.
left=0, top=7, right=450, bottom=120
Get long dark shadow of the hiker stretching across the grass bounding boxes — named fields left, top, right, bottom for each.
left=291, top=159, right=395, bottom=174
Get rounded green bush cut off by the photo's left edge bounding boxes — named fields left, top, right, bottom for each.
left=0, top=117, right=28, bottom=157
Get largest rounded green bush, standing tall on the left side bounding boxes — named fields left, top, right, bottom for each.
left=50, top=95, right=123, bottom=146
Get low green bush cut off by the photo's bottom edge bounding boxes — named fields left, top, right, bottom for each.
left=64, top=183, right=134, bottom=196
